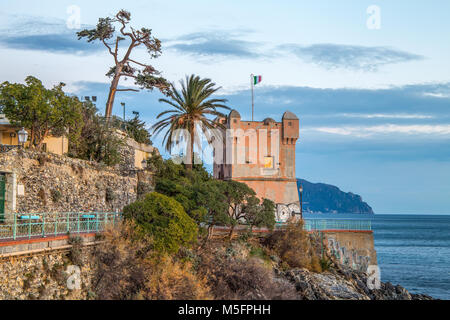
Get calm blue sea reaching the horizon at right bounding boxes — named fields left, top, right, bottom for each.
left=305, top=214, right=450, bottom=300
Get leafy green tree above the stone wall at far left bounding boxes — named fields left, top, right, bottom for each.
left=0, top=76, right=83, bottom=149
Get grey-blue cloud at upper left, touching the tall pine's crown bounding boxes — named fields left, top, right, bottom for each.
left=0, top=16, right=104, bottom=55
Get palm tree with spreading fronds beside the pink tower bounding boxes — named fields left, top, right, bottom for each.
left=153, top=75, right=230, bottom=169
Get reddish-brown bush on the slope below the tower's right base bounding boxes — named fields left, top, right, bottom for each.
left=266, top=220, right=322, bottom=272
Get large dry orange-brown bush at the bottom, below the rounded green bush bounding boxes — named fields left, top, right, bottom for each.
left=92, top=222, right=210, bottom=300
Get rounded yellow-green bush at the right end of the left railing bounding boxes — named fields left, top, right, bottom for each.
left=124, top=192, right=198, bottom=253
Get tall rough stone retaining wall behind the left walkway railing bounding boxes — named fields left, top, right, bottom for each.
left=0, top=150, right=151, bottom=217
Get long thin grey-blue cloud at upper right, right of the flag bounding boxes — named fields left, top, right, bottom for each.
left=278, top=43, right=424, bottom=71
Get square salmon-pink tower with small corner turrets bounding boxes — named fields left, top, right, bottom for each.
left=214, top=110, right=300, bottom=221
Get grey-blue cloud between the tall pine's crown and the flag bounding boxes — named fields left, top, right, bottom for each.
left=168, top=31, right=262, bottom=58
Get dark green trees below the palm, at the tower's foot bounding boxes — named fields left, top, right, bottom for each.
left=149, top=153, right=275, bottom=239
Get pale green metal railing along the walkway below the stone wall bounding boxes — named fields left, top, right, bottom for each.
left=0, top=212, right=122, bottom=241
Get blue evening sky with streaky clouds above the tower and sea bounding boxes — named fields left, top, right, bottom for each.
left=0, top=0, right=450, bottom=214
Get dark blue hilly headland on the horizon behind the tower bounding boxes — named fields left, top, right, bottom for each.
left=297, top=179, right=374, bottom=214
